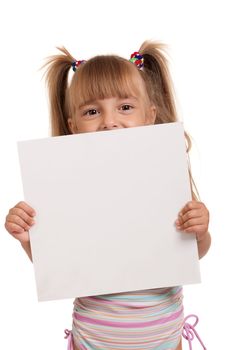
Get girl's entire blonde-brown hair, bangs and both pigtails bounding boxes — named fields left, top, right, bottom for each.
left=42, top=41, right=199, bottom=200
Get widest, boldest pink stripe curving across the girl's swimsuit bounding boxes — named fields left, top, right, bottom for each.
left=73, top=308, right=183, bottom=328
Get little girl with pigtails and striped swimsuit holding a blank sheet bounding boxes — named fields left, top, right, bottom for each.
left=5, top=42, right=211, bottom=350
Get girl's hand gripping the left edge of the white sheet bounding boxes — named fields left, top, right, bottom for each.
left=5, top=202, right=35, bottom=244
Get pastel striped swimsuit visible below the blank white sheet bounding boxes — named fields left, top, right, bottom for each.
left=66, top=287, right=184, bottom=350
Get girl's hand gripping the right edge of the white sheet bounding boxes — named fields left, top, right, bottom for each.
left=175, top=200, right=209, bottom=242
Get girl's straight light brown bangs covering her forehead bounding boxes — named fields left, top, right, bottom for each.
left=70, top=56, right=143, bottom=109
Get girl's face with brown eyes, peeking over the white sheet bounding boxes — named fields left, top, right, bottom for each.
left=68, top=76, right=156, bottom=134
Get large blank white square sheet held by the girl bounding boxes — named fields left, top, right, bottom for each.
left=18, top=123, right=200, bottom=301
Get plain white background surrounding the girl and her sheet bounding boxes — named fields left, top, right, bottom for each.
left=0, top=0, right=232, bottom=350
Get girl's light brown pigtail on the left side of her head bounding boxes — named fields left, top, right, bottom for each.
left=43, top=47, right=75, bottom=136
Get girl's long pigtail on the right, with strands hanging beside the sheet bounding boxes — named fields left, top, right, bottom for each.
left=139, top=41, right=200, bottom=200
